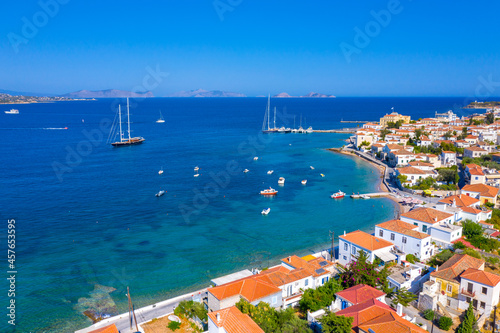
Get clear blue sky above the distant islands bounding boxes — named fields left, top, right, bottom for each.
left=0, top=0, right=500, bottom=96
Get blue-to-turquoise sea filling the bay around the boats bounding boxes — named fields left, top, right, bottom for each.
left=0, top=98, right=484, bottom=332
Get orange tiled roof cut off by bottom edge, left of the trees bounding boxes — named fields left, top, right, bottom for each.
left=208, top=306, right=264, bottom=333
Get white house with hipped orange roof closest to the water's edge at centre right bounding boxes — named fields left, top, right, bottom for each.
left=339, top=230, right=397, bottom=266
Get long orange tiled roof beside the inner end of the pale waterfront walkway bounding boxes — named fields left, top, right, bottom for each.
left=208, top=274, right=281, bottom=303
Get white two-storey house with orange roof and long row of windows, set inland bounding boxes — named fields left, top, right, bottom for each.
left=375, top=220, right=435, bottom=260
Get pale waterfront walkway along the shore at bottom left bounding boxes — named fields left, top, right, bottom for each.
left=75, top=288, right=207, bottom=333
